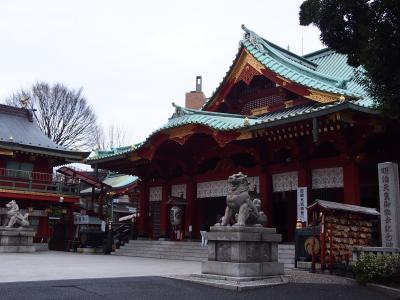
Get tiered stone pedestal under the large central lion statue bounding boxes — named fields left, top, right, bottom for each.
left=201, top=226, right=284, bottom=281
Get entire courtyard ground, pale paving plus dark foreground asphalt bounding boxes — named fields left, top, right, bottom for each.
left=0, top=252, right=390, bottom=300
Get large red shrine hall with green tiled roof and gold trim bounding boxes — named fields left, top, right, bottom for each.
left=87, top=26, right=400, bottom=242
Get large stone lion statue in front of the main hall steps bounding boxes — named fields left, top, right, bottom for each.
left=215, top=172, right=267, bottom=226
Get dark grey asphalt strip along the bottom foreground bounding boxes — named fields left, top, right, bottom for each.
left=0, top=277, right=390, bottom=300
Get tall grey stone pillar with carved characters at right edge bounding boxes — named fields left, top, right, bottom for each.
left=378, top=162, right=400, bottom=248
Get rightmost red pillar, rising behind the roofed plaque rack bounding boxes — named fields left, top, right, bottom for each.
left=343, top=161, right=361, bottom=205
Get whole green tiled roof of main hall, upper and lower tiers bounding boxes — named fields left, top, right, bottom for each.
left=89, top=26, right=374, bottom=161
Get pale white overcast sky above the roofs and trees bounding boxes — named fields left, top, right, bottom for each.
left=0, top=0, right=323, bottom=148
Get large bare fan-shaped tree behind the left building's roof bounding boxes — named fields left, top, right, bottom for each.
left=5, top=82, right=97, bottom=149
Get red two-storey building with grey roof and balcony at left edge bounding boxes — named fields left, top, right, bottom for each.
left=0, top=104, right=89, bottom=249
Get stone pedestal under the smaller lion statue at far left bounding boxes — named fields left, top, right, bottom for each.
left=0, top=227, right=35, bottom=253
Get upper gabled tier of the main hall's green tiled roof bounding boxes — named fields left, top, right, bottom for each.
left=204, top=26, right=372, bottom=108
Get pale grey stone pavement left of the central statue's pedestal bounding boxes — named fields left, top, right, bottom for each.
left=0, top=251, right=200, bottom=282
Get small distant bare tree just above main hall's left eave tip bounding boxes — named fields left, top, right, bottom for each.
left=96, top=123, right=127, bottom=150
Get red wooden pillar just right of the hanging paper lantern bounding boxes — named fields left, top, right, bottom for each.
left=185, top=180, right=199, bottom=237
